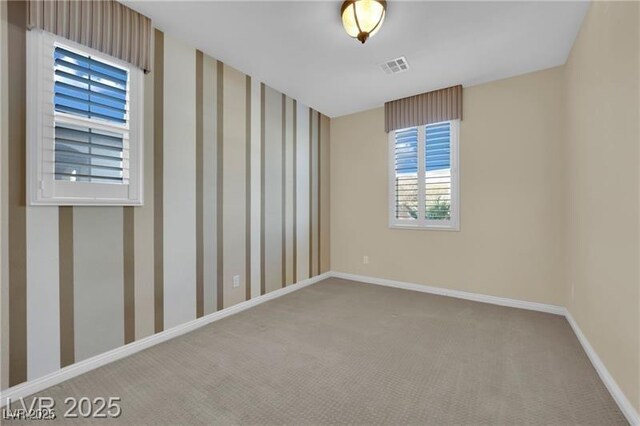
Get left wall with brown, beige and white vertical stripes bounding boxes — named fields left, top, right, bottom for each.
left=0, top=2, right=329, bottom=389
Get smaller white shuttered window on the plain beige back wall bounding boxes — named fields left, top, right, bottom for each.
left=389, top=120, right=460, bottom=231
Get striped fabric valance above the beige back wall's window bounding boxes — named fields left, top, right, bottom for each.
left=384, top=85, right=462, bottom=133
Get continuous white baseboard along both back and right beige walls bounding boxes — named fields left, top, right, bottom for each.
left=331, top=272, right=640, bottom=426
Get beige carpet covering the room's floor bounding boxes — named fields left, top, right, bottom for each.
left=13, top=279, right=626, bottom=425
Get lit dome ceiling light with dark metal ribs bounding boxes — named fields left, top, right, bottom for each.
left=340, top=0, right=387, bottom=44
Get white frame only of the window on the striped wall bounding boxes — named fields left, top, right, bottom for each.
left=26, top=29, right=144, bottom=206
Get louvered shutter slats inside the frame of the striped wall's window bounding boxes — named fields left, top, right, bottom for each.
left=54, top=46, right=129, bottom=184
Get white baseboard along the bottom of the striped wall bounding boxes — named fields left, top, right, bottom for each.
left=0, top=272, right=330, bottom=407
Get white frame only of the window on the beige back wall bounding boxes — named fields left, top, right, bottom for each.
left=387, top=119, right=460, bottom=231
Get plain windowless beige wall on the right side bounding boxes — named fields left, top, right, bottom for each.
left=564, top=2, right=640, bottom=411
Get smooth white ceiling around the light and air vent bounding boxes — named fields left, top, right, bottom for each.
left=124, top=0, right=589, bottom=117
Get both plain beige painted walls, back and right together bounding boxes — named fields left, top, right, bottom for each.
left=330, top=2, right=640, bottom=410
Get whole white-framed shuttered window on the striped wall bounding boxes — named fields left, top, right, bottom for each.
left=27, top=30, right=143, bottom=205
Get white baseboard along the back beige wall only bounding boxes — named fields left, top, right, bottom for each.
left=331, top=272, right=565, bottom=315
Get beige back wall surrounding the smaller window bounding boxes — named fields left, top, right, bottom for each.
left=330, top=68, right=564, bottom=305
